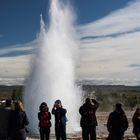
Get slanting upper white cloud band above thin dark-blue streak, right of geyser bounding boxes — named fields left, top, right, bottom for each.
left=78, top=0, right=140, bottom=37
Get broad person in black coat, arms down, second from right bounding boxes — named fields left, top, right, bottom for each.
left=107, top=103, right=128, bottom=140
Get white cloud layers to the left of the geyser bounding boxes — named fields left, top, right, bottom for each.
left=0, top=40, right=37, bottom=81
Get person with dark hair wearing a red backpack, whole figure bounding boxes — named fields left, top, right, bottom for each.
left=38, top=102, right=51, bottom=140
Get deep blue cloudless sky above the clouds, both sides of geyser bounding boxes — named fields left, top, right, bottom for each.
left=0, top=0, right=132, bottom=47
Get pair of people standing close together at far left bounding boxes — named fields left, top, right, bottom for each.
left=0, top=100, right=29, bottom=140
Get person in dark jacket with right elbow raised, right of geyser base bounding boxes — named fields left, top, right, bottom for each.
left=79, top=98, right=99, bottom=140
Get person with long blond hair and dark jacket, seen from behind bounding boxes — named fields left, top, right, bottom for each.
left=10, top=101, right=29, bottom=140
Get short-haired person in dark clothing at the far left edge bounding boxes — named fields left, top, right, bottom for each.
left=0, top=99, right=12, bottom=140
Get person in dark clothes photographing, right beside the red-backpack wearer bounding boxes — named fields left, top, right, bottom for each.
left=52, top=100, right=67, bottom=140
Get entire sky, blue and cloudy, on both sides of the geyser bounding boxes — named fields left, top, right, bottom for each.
left=0, top=0, right=140, bottom=83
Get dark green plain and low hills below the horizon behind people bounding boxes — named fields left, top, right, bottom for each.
left=0, top=84, right=140, bottom=111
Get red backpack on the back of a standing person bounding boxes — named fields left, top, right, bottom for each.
left=40, top=112, right=51, bottom=128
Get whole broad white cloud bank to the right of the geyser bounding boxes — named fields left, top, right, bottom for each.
left=78, top=1, right=140, bottom=84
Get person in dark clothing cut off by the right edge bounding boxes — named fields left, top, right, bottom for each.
left=132, top=108, right=140, bottom=140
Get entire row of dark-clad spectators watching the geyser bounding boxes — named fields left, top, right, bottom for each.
left=0, top=98, right=140, bottom=140
